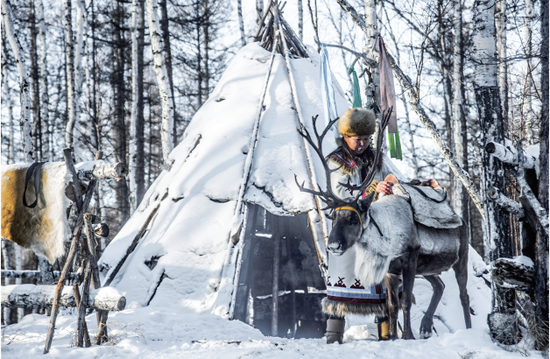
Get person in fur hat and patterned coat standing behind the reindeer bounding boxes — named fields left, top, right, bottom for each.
left=323, top=108, right=405, bottom=344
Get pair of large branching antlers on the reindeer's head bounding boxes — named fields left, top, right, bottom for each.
left=300, top=107, right=393, bottom=209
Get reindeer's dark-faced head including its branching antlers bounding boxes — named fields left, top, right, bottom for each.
left=296, top=108, right=392, bottom=255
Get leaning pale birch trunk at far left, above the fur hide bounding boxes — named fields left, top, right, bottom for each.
left=0, top=0, right=34, bottom=162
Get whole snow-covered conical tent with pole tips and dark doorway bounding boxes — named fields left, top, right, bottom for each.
left=100, top=7, right=348, bottom=335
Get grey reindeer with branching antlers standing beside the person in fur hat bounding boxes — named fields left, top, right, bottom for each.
left=295, top=108, right=472, bottom=339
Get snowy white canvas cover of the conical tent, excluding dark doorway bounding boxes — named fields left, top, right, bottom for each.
left=100, top=43, right=348, bottom=315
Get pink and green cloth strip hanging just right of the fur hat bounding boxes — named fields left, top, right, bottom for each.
left=378, top=36, right=403, bottom=160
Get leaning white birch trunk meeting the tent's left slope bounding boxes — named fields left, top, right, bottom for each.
left=146, top=0, right=174, bottom=166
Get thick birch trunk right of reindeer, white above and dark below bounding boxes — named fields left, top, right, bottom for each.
left=472, top=0, right=521, bottom=345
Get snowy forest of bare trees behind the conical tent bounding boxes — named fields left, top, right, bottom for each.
left=0, top=0, right=542, bottom=334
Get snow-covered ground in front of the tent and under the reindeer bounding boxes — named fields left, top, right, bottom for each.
left=0, top=253, right=543, bottom=359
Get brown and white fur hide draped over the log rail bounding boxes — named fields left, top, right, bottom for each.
left=0, top=162, right=70, bottom=263
